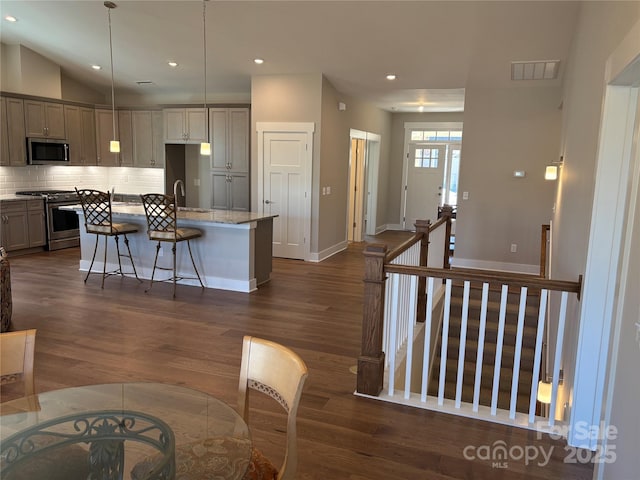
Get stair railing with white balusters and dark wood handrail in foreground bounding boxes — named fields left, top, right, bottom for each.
left=357, top=218, right=582, bottom=426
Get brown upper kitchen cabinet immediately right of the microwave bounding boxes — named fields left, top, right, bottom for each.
left=64, top=105, right=97, bottom=165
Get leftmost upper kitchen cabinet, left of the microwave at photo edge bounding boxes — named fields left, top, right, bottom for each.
left=0, top=97, right=27, bottom=167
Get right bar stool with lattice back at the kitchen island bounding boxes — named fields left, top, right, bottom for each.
left=140, top=193, right=204, bottom=298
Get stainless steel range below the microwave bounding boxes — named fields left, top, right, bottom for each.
left=16, top=190, right=80, bottom=250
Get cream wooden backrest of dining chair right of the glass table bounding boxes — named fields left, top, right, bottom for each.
left=238, top=336, right=308, bottom=480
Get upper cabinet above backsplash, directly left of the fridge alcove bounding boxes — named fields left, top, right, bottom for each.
left=131, top=110, right=164, bottom=168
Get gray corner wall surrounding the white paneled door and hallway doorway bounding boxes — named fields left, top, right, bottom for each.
left=251, top=74, right=391, bottom=254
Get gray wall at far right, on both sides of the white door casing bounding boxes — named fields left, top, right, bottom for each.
left=551, top=2, right=640, bottom=479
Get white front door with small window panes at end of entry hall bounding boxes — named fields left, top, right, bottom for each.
left=403, top=143, right=446, bottom=230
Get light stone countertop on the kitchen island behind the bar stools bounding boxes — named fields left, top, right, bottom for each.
left=60, top=202, right=278, bottom=225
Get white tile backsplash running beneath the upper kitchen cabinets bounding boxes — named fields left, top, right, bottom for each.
left=0, top=165, right=164, bottom=195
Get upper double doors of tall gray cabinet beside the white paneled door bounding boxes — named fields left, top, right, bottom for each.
left=209, top=108, right=249, bottom=172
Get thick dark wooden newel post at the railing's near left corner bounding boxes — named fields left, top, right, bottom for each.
left=356, top=244, right=387, bottom=396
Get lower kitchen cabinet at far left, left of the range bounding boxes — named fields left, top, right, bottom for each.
left=0, top=200, right=47, bottom=252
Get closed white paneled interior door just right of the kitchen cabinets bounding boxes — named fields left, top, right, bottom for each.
left=262, top=131, right=311, bottom=260
